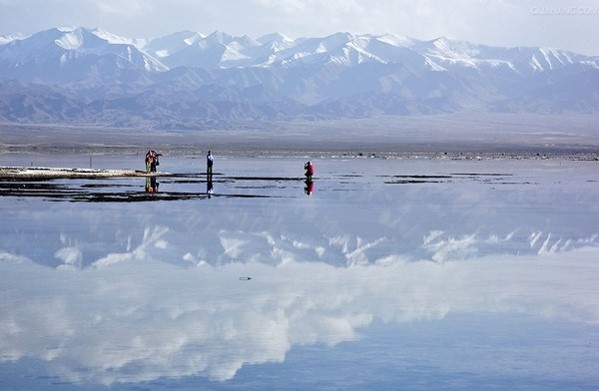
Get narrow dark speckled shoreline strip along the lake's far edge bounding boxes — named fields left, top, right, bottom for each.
left=0, top=147, right=599, bottom=162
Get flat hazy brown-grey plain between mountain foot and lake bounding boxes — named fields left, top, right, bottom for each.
left=0, top=114, right=599, bottom=160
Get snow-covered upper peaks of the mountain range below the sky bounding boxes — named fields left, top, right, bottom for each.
left=0, top=26, right=599, bottom=78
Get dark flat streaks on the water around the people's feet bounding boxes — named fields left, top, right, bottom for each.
left=0, top=172, right=529, bottom=202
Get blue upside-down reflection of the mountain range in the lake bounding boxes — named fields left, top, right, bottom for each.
left=3, top=159, right=599, bottom=268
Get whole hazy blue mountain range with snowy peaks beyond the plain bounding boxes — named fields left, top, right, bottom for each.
left=0, top=27, right=599, bottom=129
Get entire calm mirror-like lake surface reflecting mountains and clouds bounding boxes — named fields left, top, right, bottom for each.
left=0, top=155, right=599, bottom=390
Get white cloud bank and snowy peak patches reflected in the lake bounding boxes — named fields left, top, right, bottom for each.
left=0, top=234, right=599, bottom=384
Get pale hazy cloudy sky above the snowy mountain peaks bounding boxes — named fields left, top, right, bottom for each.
left=0, top=0, right=599, bottom=55
